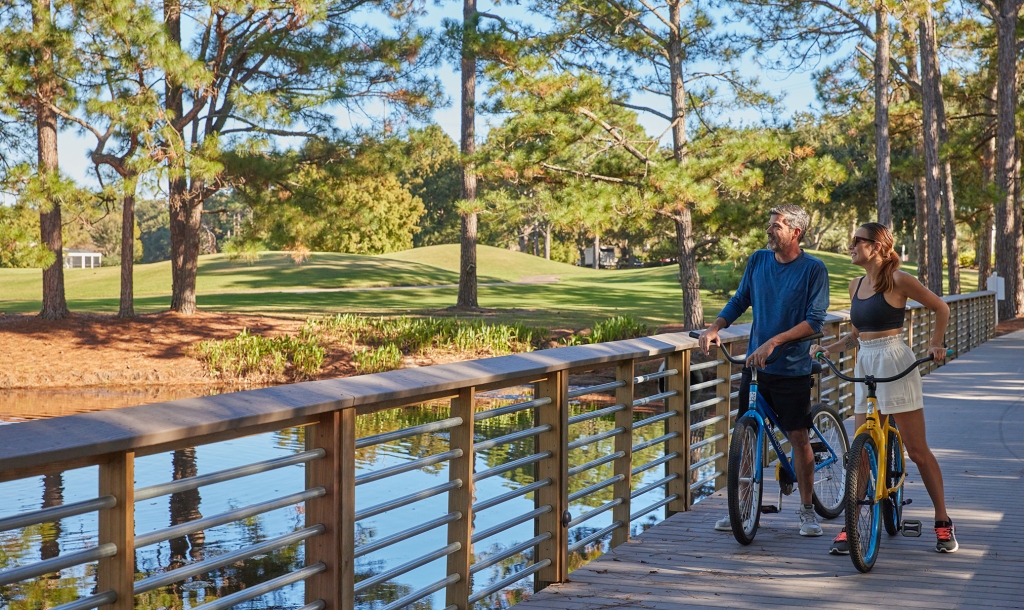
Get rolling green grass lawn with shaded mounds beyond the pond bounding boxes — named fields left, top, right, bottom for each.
left=0, top=246, right=977, bottom=330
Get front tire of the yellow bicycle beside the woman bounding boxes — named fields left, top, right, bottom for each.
left=846, top=432, right=882, bottom=572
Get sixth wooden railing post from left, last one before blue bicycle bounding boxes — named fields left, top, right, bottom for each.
left=665, top=350, right=692, bottom=518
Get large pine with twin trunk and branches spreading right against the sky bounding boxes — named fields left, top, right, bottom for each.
left=162, top=0, right=439, bottom=314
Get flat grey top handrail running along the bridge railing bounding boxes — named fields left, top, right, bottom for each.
left=0, top=292, right=993, bottom=480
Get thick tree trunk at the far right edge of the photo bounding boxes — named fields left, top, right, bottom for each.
left=992, top=0, right=1024, bottom=319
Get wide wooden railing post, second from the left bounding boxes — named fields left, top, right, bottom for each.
left=305, top=408, right=355, bottom=610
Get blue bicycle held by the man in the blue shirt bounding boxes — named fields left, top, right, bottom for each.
left=690, top=331, right=850, bottom=544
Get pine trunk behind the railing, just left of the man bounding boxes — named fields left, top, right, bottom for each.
left=669, top=0, right=705, bottom=331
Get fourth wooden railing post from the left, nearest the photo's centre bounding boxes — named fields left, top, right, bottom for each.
left=534, top=371, right=569, bottom=591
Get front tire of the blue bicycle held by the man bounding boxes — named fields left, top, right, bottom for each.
left=728, top=416, right=764, bottom=544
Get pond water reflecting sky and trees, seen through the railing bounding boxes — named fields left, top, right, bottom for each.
left=0, top=388, right=720, bottom=610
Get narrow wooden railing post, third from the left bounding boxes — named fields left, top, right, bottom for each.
left=444, top=388, right=476, bottom=610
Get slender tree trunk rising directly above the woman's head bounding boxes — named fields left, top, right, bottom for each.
left=874, top=0, right=893, bottom=228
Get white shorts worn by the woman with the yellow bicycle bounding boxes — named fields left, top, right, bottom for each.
left=853, top=335, right=925, bottom=415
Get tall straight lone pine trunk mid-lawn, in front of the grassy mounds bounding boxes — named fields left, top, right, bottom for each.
left=456, top=0, right=478, bottom=308
